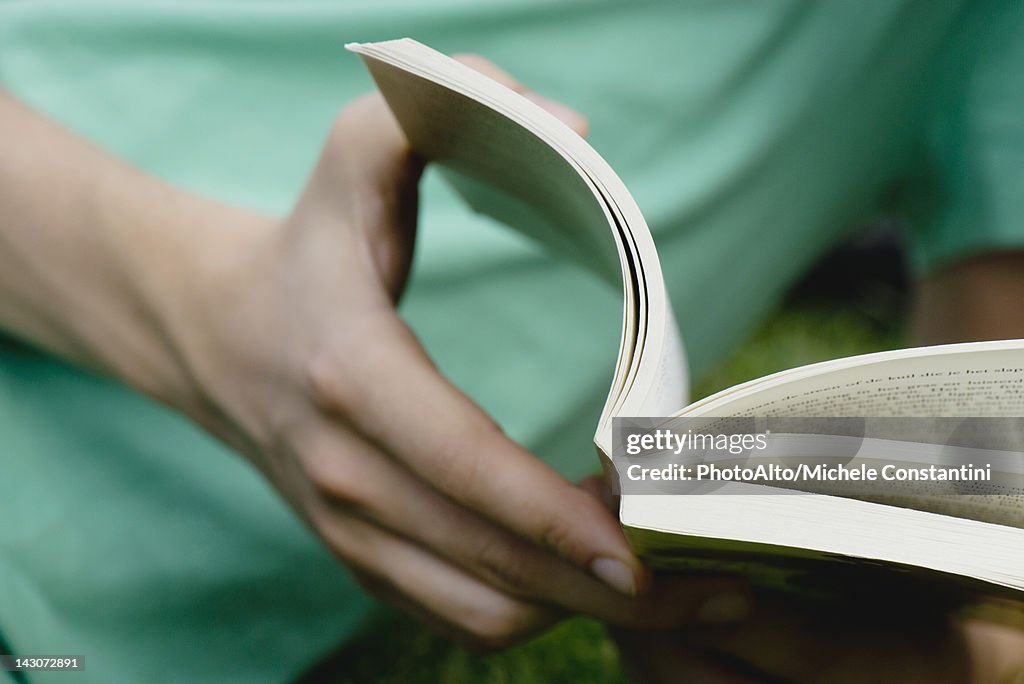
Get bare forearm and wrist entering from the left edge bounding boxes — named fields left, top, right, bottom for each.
left=0, top=92, right=279, bottom=456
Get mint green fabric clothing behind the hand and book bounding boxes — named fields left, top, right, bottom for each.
left=0, top=0, right=1024, bottom=682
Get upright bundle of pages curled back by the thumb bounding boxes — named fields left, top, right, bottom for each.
left=348, top=39, right=687, bottom=454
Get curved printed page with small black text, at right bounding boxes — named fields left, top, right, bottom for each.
left=680, top=340, right=1024, bottom=527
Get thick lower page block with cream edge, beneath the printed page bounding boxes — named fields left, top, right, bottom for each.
left=623, top=483, right=1024, bottom=600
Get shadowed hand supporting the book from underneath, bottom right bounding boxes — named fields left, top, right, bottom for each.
left=615, top=592, right=1024, bottom=684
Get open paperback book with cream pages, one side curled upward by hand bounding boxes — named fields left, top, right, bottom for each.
left=348, top=39, right=1024, bottom=614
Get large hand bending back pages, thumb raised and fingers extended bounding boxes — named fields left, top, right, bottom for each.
left=138, top=58, right=753, bottom=647
